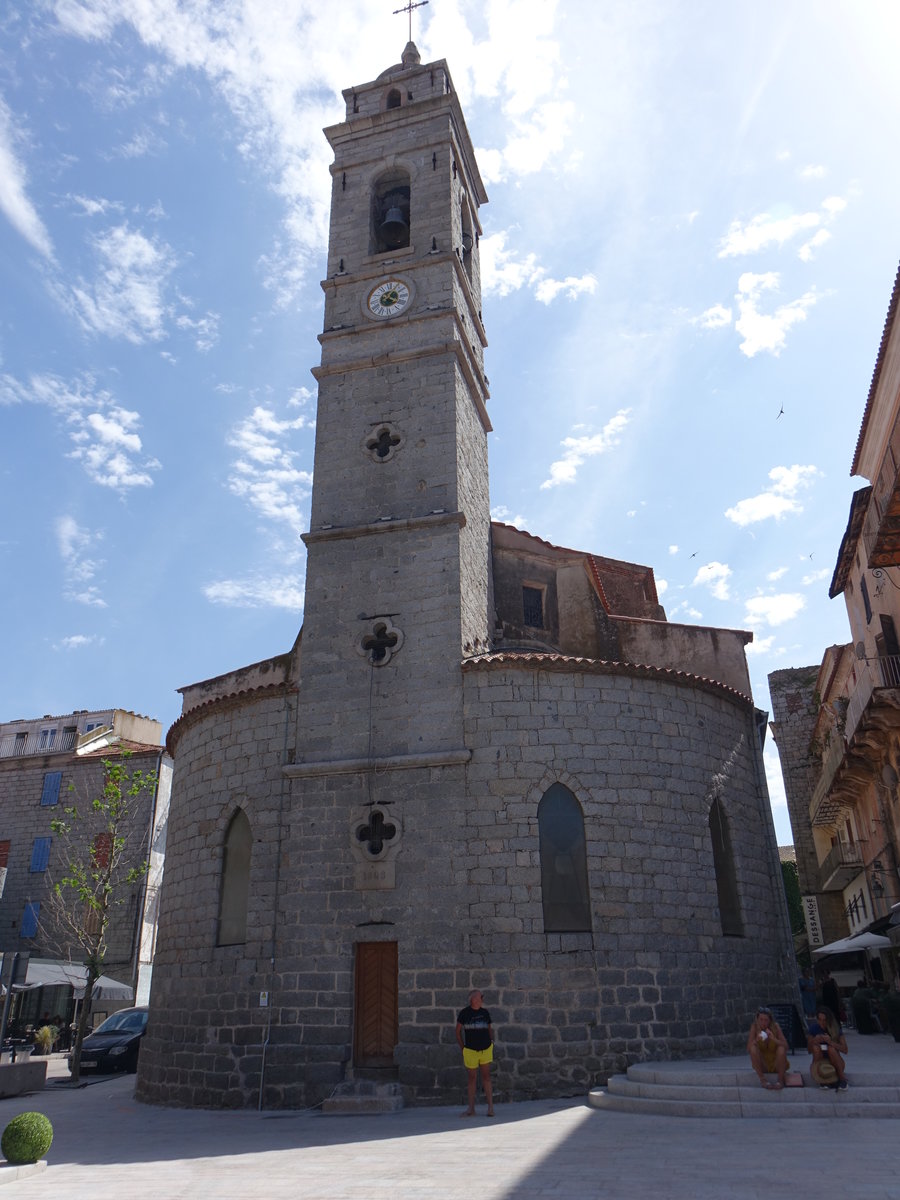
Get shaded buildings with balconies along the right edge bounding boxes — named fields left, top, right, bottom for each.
left=769, top=262, right=900, bottom=964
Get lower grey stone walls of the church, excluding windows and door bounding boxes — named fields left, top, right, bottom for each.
left=139, top=665, right=794, bottom=1108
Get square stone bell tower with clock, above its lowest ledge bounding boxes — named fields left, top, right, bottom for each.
left=298, top=42, right=491, bottom=764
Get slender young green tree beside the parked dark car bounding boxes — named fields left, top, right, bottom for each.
left=48, top=750, right=157, bottom=1082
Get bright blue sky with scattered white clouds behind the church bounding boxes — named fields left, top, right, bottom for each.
left=0, top=0, right=900, bottom=842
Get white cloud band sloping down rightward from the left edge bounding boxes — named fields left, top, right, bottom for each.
left=0, top=374, right=160, bottom=492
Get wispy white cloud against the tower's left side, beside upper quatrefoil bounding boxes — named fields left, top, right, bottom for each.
left=228, top=404, right=312, bottom=534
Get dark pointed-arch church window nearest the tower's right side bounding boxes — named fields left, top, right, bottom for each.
left=538, top=784, right=590, bottom=934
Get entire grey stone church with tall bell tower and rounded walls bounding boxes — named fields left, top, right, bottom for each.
left=138, top=42, right=794, bottom=1108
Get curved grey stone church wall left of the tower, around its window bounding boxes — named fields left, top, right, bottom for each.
left=138, top=689, right=296, bottom=1108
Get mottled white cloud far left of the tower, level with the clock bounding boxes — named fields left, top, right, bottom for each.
left=63, top=224, right=175, bottom=346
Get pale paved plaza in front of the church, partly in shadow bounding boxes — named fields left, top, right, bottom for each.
left=0, top=1037, right=900, bottom=1200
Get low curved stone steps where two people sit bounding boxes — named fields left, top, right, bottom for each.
left=588, top=1062, right=900, bottom=1120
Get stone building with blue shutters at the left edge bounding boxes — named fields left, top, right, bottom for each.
left=0, top=709, right=172, bottom=1007
